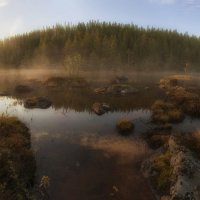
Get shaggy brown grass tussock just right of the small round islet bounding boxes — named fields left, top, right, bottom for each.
left=152, top=100, right=184, bottom=124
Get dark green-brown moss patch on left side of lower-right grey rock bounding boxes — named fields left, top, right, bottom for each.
left=151, top=151, right=173, bottom=194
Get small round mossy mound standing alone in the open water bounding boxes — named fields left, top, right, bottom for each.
left=117, top=119, right=134, bottom=135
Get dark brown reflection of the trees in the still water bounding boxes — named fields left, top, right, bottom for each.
left=49, top=89, right=163, bottom=112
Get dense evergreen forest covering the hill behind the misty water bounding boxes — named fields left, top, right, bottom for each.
left=0, top=21, right=200, bottom=70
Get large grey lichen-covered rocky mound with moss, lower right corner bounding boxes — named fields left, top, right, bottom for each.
left=142, top=133, right=200, bottom=200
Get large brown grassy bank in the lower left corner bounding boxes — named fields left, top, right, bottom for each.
left=0, top=117, right=36, bottom=200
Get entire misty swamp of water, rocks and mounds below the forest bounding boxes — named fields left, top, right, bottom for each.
left=0, top=69, right=200, bottom=200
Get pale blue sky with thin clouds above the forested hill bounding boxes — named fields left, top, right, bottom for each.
left=0, top=0, right=200, bottom=39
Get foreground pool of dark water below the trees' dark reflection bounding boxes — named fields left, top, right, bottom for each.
left=0, top=97, right=153, bottom=200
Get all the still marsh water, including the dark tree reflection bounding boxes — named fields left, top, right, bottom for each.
left=0, top=69, right=200, bottom=200
